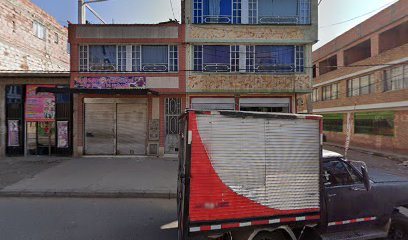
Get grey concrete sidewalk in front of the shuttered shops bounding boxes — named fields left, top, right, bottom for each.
left=0, top=157, right=178, bottom=198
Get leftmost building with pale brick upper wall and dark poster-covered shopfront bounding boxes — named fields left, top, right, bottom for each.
left=0, top=0, right=71, bottom=157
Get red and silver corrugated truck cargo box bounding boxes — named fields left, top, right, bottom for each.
left=178, top=110, right=322, bottom=239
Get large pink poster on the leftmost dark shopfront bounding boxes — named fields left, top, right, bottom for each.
left=25, top=85, right=55, bottom=122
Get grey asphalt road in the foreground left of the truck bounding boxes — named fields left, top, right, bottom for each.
left=0, top=198, right=177, bottom=240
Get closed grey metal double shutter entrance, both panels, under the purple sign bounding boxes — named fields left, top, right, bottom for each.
left=85, top=98, right=147, bottom=155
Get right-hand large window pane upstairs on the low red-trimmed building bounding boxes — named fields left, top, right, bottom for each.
left=142, top=46, right=169, bottom=72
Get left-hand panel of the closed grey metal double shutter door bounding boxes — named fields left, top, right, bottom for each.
left=85, top=103, right=116, bottom=155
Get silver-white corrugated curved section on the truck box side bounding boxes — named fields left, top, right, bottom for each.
left=196, top=114, right=320, bottom=210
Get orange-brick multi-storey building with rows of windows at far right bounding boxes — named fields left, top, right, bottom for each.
left=299, top=0, right=408, bottom=154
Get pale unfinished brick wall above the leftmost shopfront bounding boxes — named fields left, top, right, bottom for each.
left=0, top=0, right=69, bottom=71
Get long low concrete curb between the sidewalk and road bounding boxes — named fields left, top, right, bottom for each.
left=0, top=191, right=177, bottom=199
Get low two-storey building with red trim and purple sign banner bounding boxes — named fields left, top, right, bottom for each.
left=69, top=22, right=186, bottom=156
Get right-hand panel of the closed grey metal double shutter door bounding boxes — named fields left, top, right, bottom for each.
left=116, top=103, right=147, bottom=155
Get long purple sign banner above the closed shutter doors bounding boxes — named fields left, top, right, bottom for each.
left=74, top=77, right=146, bottom=89
